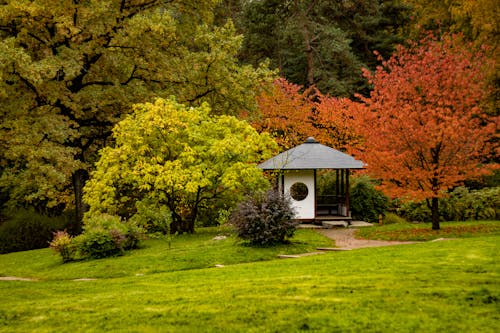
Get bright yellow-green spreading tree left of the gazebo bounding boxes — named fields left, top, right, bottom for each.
left=85, top=99, right=277, bottom=233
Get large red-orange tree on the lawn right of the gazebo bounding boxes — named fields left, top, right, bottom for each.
left=354, top=36, right=499, bottom=230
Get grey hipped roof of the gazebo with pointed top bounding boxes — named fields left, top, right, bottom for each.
left=259, top=137, right=364, bottom=170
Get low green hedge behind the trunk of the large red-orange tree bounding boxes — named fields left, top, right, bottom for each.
left=398, top=186, right=500, bottom=222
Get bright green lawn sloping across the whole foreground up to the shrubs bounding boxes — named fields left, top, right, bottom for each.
left=0, top=224, right=500, bottom=332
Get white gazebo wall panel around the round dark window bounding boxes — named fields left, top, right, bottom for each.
left=283, top=170, right=316, bottom=219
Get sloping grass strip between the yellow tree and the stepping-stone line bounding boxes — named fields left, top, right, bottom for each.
left=0, top=228, right=333, bottom=280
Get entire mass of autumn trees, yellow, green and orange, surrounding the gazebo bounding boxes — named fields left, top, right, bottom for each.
left=0, top=0, right=500, bottom=245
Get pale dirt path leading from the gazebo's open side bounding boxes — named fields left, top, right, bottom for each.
left=317, top=228, right=417, bottom=250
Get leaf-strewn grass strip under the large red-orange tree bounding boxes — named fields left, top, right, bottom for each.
left=356, top=221, right=500, bottom=241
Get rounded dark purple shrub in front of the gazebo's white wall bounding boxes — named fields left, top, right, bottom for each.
left=230, top=190, right=296, bottom=245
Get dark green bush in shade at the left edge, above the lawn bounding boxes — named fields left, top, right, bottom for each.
left=0, top=210, right=70, bottom=253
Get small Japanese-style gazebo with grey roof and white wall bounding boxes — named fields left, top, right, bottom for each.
left=259, top=137, right=364, bottom=221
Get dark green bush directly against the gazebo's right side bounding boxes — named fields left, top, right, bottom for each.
left=350, top=176, right=389, bottom=222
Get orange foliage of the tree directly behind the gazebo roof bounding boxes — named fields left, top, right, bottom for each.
left=252, top=78, right=356, bottom=150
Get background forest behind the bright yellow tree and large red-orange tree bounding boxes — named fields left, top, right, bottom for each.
left=0, top=0, right=499, bottom=249
